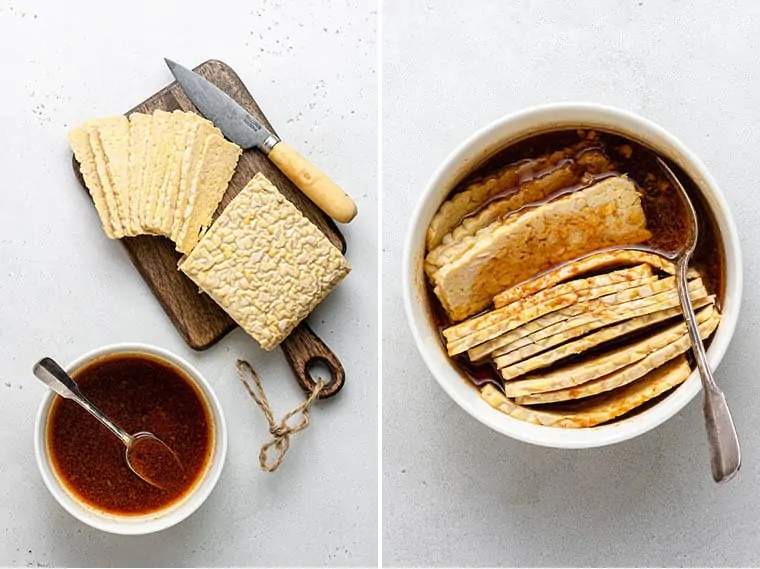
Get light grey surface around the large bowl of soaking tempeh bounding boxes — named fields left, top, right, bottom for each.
left=382, top=0, right=760, bottom=567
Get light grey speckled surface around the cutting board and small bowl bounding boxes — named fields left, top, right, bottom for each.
left=0, top=0, right=378, bottom=567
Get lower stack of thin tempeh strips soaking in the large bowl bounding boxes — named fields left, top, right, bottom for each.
left=444, top=250, right=720, bottom=428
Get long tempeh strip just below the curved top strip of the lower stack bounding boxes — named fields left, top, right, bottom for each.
left=443, top=265, right=652, bottom=343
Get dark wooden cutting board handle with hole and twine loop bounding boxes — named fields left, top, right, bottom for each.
left=280, top=322, right=346, bottom=399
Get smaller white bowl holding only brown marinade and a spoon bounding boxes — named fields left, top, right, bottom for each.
left=34, top=344, right=227, bottom=535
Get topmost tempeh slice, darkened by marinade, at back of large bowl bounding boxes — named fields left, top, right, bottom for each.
left=426, top=141, right=593, bottom=250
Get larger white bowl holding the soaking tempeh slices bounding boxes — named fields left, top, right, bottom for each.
left=403, top=103, right=742, bottom=448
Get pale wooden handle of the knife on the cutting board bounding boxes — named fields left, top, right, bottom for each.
left=269, top=142, right=356, bottom=223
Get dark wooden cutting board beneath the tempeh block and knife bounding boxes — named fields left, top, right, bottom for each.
left=74, top=60, right=346, bottom=392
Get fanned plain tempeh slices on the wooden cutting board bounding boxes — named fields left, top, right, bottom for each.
left=69, top=110, right=241, bottom=253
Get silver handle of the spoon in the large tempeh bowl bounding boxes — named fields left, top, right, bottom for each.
left=677, top=258, right=742, bottom=483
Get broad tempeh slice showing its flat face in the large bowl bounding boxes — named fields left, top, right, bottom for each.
left=433, top=177, right=651, bottom=321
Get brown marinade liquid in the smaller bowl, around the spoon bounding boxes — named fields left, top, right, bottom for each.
left=47, top=354, right=213, bottom=515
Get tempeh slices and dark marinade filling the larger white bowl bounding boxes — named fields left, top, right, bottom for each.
left=425, top=129, right=725, bottom=427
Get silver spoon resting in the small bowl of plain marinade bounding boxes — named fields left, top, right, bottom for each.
left=32, top=358, right=182, bottom=490
